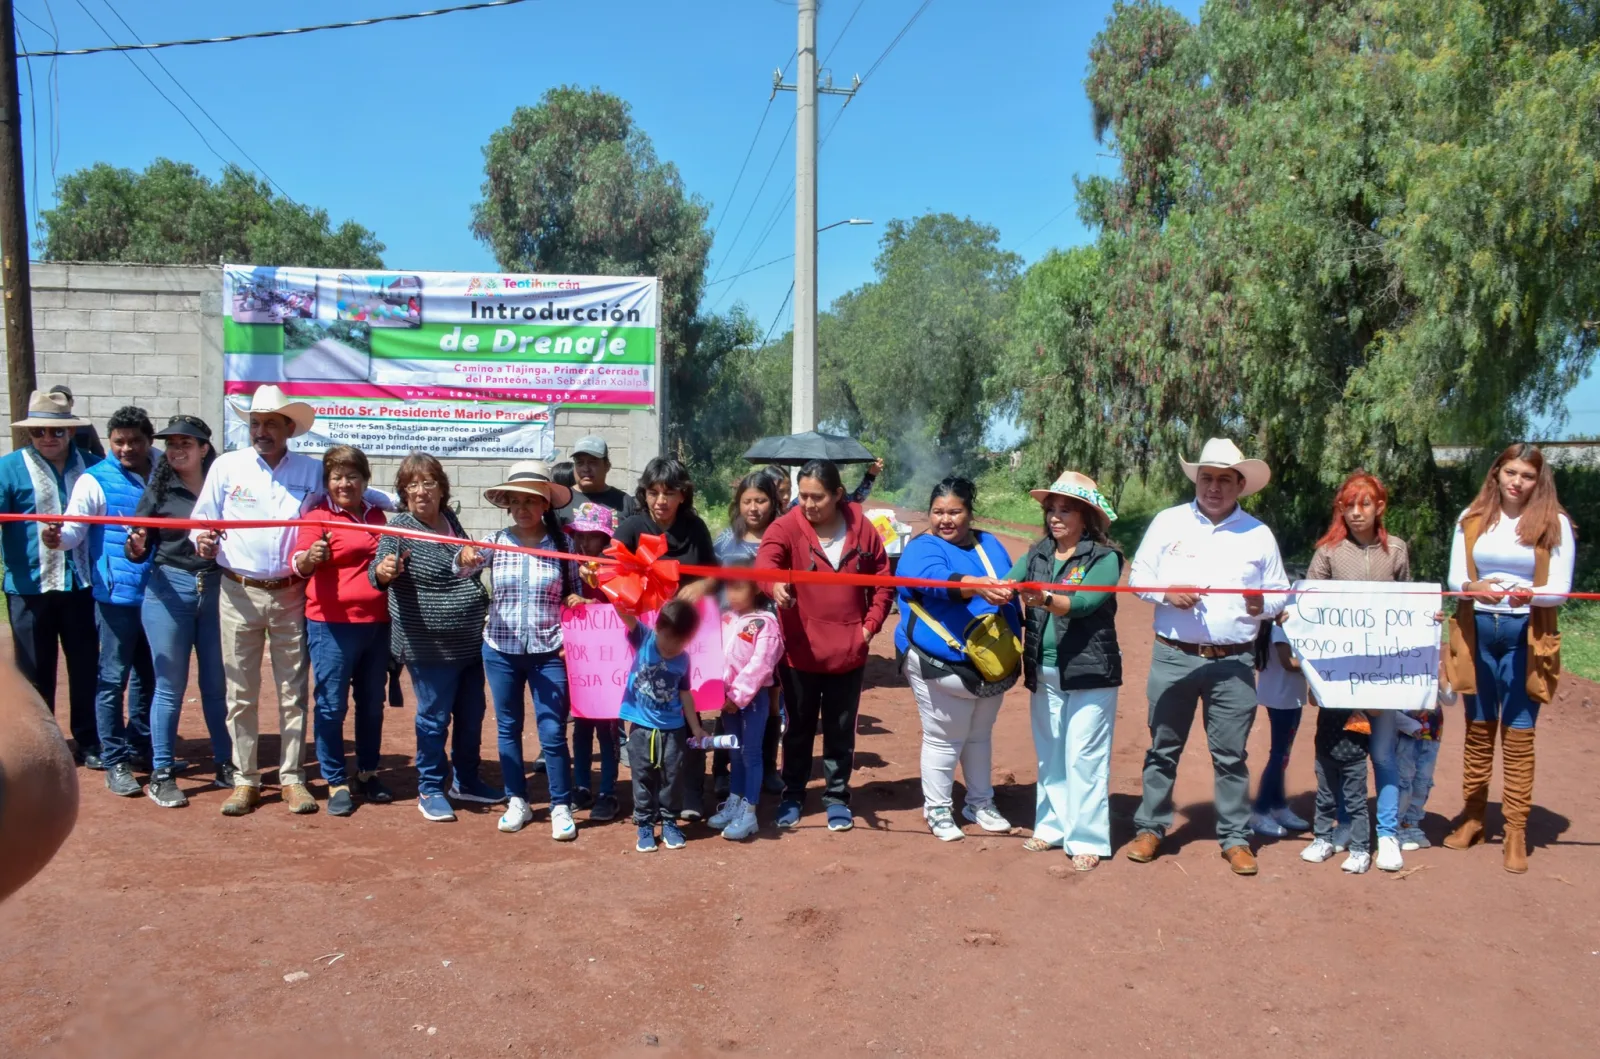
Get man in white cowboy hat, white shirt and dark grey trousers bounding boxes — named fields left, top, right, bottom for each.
left=1128, top=438, right=1290, bottom=875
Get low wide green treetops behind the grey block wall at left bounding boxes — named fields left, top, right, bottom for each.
left=37, top=158, right=384, bottom=269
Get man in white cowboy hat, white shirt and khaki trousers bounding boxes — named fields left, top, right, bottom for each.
left=189, top=384, right=394, bottom=816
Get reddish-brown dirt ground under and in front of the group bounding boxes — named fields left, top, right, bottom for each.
left=0, top=524, right=1600, bottom=1057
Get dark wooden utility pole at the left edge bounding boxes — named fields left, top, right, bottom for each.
left=0, top=0, right=35, bottom=448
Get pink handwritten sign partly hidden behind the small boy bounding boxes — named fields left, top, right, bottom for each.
left=562, top=598, right=728, bottom=720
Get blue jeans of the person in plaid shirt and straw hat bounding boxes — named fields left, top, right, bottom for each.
left=483, top=643, right=573, bottom=806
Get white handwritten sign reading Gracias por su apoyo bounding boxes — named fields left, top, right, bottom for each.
left=1283, top=581, right=1440, bottom=710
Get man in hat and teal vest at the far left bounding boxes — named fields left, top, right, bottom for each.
left=0, top=390, right=101, bottom=768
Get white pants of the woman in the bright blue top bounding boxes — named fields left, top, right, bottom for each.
left=906, top=651, right=1000, bottom=813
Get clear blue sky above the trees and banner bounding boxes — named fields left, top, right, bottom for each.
left=16, top=0, right=1600, bottom=434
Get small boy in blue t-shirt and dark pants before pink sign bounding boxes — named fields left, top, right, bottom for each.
left=618, top=600, right=706, bottom=853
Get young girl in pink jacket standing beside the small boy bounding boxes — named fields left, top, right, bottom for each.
left=709, top=581, right=784, bottom=841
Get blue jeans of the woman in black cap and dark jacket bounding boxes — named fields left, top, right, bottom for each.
left=144, top=565, right=234, bottom=768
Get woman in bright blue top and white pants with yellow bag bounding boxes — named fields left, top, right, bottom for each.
left=894, top=478, right=1021, bottom=841
